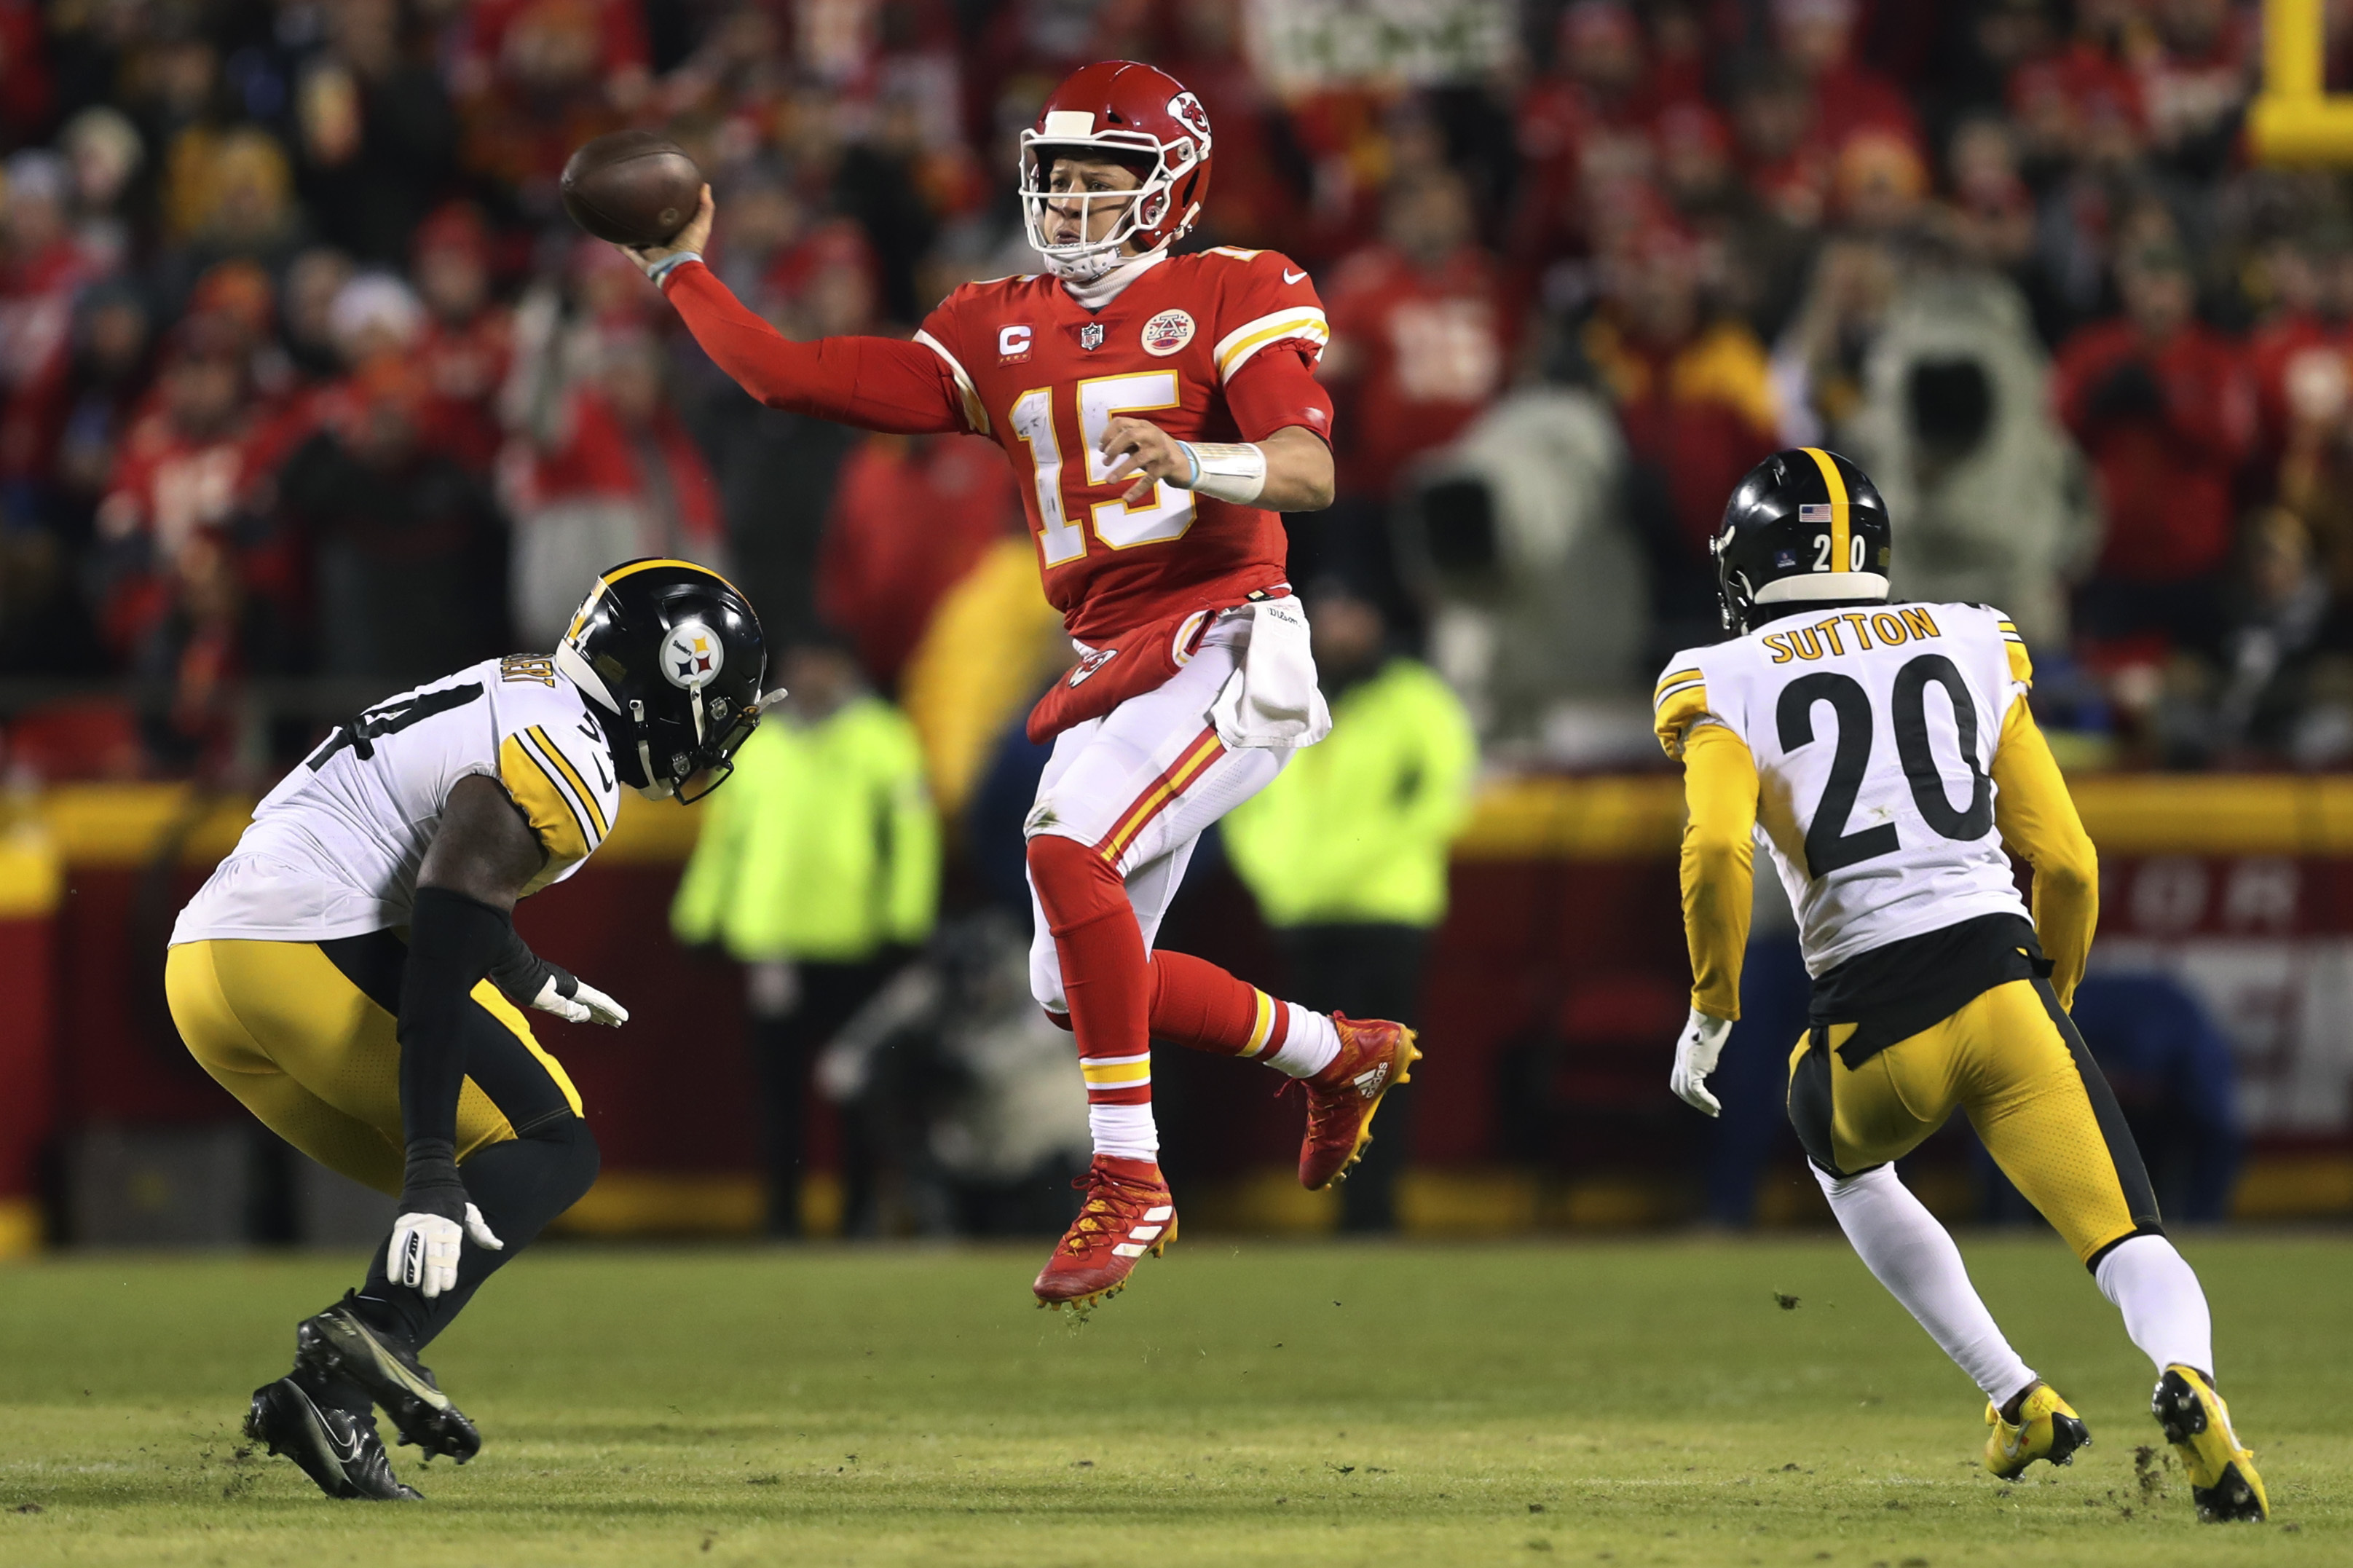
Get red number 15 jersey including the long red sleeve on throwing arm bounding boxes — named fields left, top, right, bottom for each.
left=666, top=250, right=1332, bottom=643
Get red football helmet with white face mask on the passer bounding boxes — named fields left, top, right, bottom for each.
left=1021, top=59, right=1210, bottom=283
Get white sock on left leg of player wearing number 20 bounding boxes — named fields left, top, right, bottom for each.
left=1810, top=1165, right=2035, bottom=1406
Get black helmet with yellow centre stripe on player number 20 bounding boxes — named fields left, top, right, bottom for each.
left=1708, top=447, right=1894, bottom=636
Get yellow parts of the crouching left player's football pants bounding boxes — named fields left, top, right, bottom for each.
left=165, top=939, right=581, bottom=1194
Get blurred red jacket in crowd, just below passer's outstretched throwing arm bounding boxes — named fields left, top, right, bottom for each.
left=816, top=436, right=1021, bottom=685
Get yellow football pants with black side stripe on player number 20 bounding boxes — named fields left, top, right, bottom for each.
left=1789, top=980, right=2162, bottom=1264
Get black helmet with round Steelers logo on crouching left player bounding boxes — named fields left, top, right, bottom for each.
left=556, top=558, right=784, bottom=803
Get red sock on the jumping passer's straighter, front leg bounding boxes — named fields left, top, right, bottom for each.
left=1028, top=833, right=1153, bottom=1106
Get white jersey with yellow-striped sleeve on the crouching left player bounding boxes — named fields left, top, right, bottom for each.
left=172, top=655, right=621, bottom=944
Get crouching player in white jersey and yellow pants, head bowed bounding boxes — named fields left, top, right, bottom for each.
left=165, top=560, right=776, bottom=1500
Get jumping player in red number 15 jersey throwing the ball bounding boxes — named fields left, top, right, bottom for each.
left=631, top=61, right=1422, bottom=1307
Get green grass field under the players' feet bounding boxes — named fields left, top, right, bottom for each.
left=0, top=1236, right=2353, bottom=1568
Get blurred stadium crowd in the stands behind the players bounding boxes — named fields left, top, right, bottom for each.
left=0, top=0, right=2353, bottom=777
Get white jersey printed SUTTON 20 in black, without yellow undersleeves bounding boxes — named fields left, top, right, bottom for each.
left=1654, top=605, right=2033, bottom=974
